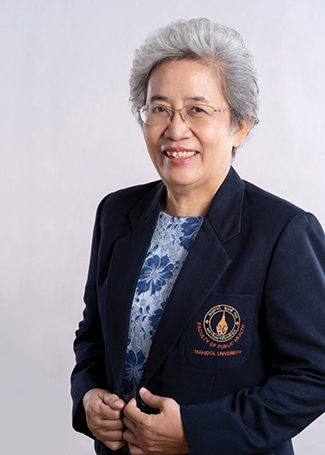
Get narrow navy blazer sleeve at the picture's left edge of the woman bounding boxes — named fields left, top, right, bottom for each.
left=71, top=200, right=107, bottom=438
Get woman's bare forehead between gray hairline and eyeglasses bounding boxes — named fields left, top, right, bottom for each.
left=147, top=60, right=224, bottom=104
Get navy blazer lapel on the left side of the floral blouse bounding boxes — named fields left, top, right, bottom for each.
left=103, top=183, right=165, bottom=394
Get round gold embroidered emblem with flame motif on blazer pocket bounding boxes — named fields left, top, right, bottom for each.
left=203, top=305, right=240, bottom=342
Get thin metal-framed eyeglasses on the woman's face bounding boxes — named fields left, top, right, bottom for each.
left=137, top=104, right=231, bottom=126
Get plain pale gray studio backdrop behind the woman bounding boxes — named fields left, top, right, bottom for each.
left=0, top=0, right=325, bottom=455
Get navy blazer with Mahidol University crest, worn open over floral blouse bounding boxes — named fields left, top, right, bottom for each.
left=72, top=168, right=325, bottom=455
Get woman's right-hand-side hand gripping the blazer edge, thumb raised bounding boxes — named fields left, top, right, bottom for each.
left=123, top=387, right=189, bottom=455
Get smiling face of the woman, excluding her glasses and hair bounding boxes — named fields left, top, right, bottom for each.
left=143, top=60, right=249, bottom=195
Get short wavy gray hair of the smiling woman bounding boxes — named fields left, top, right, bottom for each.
left=130, top=18, right=259, bottom=153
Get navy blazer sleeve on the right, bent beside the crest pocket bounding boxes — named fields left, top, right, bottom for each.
left=181, top=212, right=325, bottom=455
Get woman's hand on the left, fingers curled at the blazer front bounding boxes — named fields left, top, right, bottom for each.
left=82, top=389, right=126, bottom=450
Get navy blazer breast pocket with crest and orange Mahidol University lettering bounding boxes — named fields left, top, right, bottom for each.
left=185, top=294, right=256, bottom=369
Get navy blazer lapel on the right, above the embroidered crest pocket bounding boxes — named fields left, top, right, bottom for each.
left=141, top=168, right=244, bottom=384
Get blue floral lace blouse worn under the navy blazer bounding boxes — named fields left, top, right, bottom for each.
left=122, top=211, right=203, bottom=401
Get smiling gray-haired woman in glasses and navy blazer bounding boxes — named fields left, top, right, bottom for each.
left=72, top=19, right=325, bottom=455
